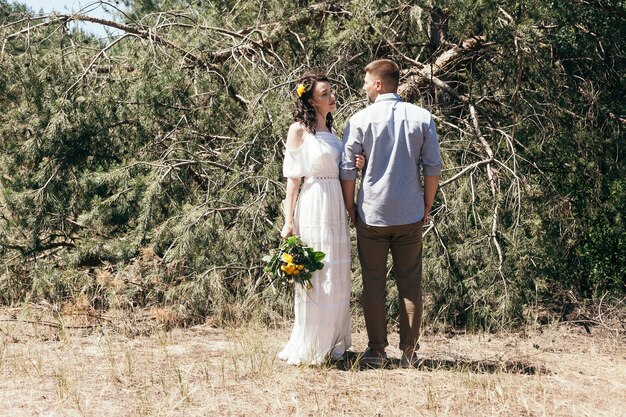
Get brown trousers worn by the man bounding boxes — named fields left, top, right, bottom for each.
left=356, top=219, right=423, bottom=350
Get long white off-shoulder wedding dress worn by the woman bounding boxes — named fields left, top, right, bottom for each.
left=278, top=132, right=352, bottom=365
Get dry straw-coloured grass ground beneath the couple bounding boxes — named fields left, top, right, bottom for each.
left=0, top=308, right=626, bottom=417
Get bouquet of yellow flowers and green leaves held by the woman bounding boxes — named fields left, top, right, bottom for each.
left=263, top=236, right=326, bottom=290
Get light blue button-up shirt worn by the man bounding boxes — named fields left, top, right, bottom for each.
left=340, top=93, right=441, bottom=226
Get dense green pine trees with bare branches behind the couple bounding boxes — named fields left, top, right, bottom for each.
left=0, top=0, right=626, bottom=330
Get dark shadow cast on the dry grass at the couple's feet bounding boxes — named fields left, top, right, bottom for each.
left=331, top=352, right=552, bottom=375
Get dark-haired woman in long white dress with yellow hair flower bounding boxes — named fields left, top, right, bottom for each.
left=278, top=74, right=365, bottom=365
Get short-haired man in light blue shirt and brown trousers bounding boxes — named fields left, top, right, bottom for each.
left=340, top=59, right=441, bottom=368
